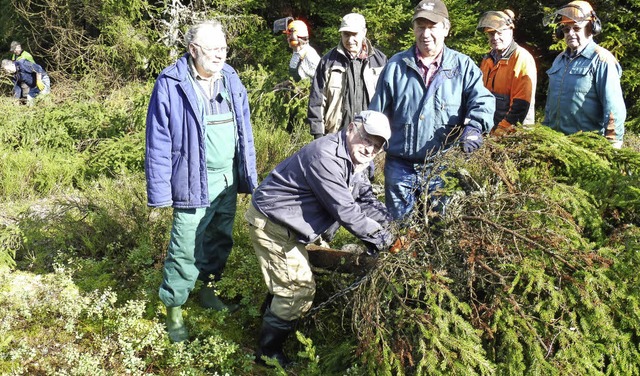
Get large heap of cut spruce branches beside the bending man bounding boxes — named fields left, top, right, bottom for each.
left=352, top=127, right=640, bottom=375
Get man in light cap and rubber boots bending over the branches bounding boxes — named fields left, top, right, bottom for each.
left=245, top=111, right=393, bottom=366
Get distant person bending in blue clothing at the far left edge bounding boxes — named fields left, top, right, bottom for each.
left=1, top=59, right=51, bottom=104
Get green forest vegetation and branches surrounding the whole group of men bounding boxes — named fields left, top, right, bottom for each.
left=0, top=0, right=640, bottom=375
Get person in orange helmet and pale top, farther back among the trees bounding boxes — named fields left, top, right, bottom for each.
left=285, top=20, right=320, bottom=82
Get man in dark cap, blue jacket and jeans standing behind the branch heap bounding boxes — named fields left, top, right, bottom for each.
left=369, top=0, right=495, bottom=220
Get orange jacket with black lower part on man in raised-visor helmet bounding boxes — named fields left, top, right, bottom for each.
left=480, top=42, right=538, bottom=128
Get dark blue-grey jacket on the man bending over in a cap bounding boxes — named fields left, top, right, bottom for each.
left=252, top=130, right=392, bottom=250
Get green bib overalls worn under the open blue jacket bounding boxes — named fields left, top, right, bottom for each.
left=160, top=78, right=238, bottom=310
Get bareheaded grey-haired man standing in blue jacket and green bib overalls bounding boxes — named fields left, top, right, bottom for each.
left=145, top=21, right=257, bottom=342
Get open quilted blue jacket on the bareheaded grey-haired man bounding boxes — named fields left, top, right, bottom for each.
left=145, top=54, right=258, bottom=208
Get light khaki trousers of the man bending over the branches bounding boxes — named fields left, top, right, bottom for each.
left=245, top=205, right=316, bottom=321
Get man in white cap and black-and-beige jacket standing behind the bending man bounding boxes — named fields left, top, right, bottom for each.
left=307, top=13, right=387, bottom=138
